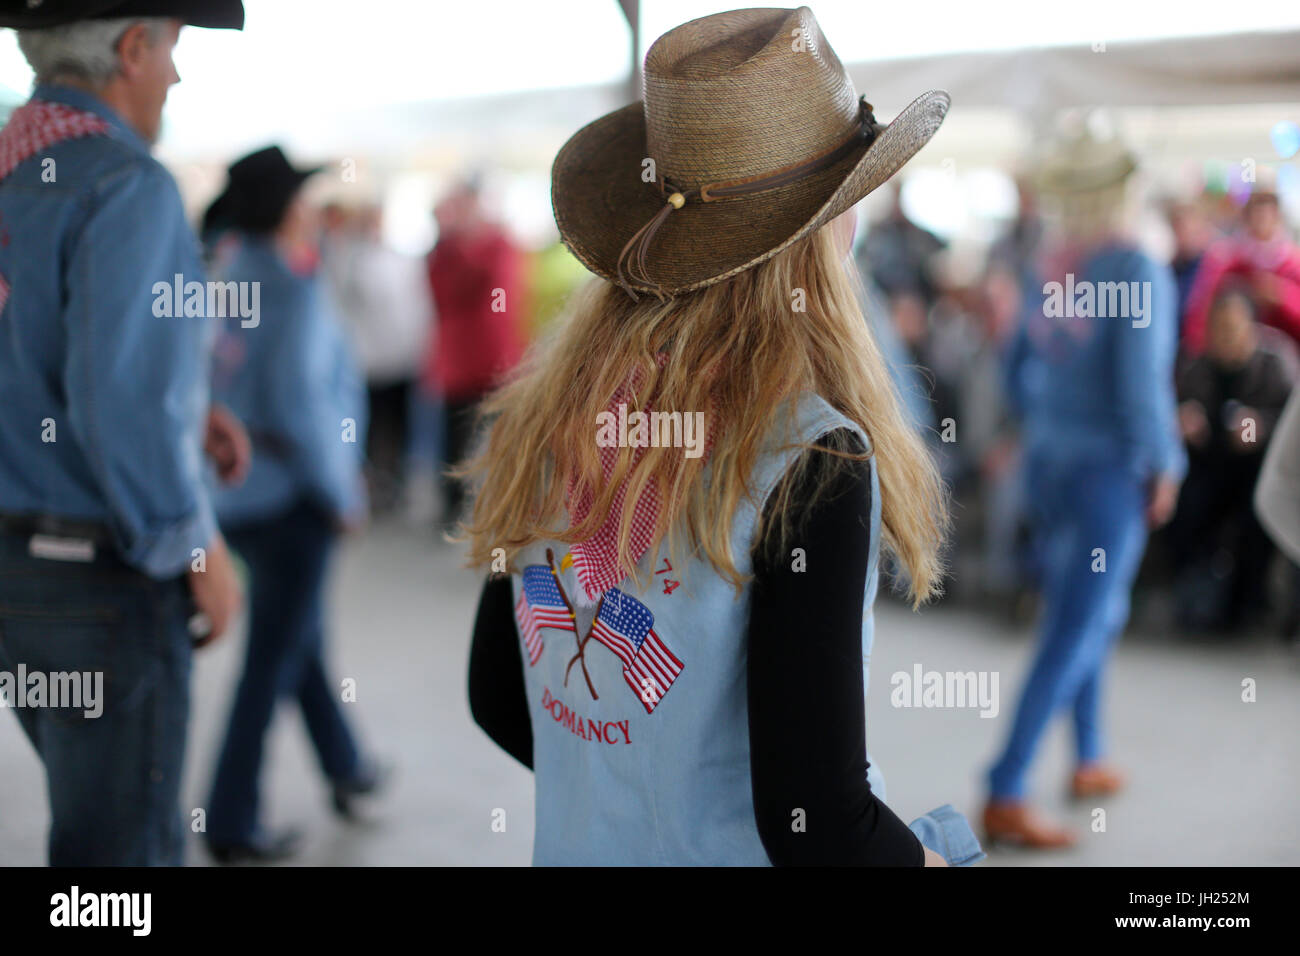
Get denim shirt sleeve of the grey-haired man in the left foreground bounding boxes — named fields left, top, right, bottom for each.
left=64, top=160, right=217, bottom=579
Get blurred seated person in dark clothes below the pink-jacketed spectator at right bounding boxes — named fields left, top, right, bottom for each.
left=1169, top=286, right=1292, bottom=632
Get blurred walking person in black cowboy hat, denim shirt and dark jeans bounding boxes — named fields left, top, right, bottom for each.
left=207, top=147, right=384, bottom=862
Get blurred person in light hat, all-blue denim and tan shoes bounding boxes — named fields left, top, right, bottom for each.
left=984, top=129, right=1186, bottom=847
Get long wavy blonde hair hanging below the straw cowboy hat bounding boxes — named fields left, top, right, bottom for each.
left=462, top=228, right=948, bottom=606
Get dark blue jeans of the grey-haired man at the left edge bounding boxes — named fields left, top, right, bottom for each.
left=0, top=536, right=194, bottom=866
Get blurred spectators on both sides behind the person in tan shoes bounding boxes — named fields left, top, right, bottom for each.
left=858, top=170, right=1300, bottom=639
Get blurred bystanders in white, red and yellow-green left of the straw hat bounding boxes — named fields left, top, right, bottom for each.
left=292, top=174, right=586, bottom=531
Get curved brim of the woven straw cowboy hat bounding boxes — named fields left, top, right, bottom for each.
left=551, top=90, right=950, bottom=297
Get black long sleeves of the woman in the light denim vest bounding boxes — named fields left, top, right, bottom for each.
left=469, top=434, right=924, bottom=866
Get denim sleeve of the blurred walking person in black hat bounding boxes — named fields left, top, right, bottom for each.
left=261, top=278, right=367, bottom=516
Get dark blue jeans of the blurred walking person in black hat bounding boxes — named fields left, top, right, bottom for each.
left=208, top=501, right=360, bottom=844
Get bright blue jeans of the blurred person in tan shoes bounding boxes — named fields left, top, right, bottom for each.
left=989, top=459, right=1147, bottom=800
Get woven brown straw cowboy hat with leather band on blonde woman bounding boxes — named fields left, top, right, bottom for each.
left=551, top=7, right=949, bottom=298
